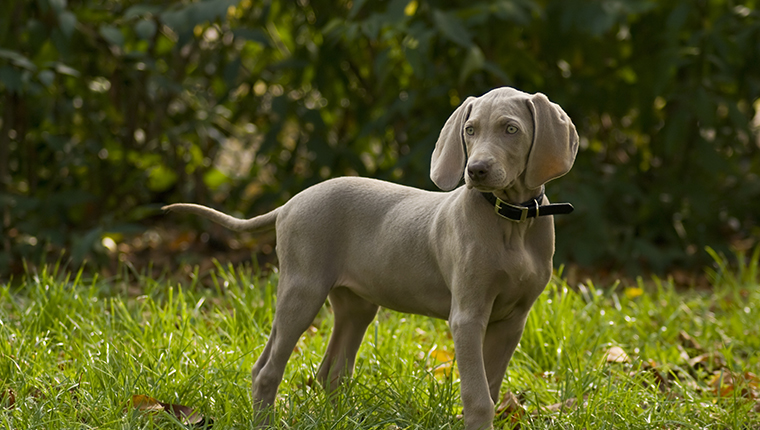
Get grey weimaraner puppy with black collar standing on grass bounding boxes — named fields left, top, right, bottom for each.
left=164, top=88, right=578, bottom=430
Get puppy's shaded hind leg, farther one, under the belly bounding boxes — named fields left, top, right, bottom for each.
left=317, top=287, right=378, bottom=392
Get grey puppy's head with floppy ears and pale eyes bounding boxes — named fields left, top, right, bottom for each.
left=430, top=87, right=578, bottom=192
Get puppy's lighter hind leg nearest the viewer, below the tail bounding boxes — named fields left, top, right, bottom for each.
left=251, top=273, right=330, bottom=425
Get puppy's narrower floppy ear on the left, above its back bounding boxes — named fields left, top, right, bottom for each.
left=430, top=97, right=476, bottom=191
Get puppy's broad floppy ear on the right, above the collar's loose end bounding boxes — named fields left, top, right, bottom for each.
left=525, top=93, right=578, bottom=188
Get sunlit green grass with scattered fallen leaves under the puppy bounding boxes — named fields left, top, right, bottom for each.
left=0, top=248, right=760, bottom=430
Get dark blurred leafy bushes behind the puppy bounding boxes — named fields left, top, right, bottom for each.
left=0, top=0, right=760, bottom=277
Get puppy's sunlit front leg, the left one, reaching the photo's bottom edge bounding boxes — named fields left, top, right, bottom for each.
left=449, top=307, right=494, bottom=430
